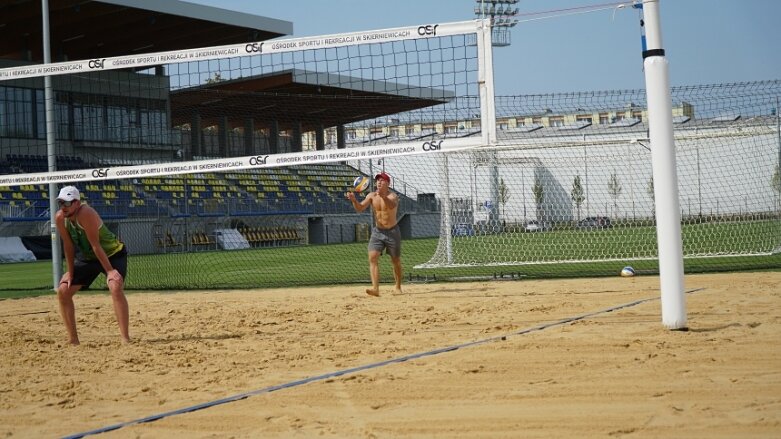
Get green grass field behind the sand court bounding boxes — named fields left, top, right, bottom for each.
left=0, top=221, right=781, bottom=298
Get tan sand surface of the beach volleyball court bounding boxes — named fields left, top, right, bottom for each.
left=0, top=273, right=781, bottom=438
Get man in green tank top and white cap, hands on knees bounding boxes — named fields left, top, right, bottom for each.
left=55, top=186, right=130, bottom=345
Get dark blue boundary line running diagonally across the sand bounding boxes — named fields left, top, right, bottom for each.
left=64, top=288, right=703, bottom=439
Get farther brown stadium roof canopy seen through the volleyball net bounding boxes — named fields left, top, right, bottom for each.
left=171, top=69, right=455, bottom=131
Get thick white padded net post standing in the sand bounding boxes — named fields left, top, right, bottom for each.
left=642, top=0, right=686, bottom=329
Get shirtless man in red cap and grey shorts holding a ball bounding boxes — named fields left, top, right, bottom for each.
left=347, top=172, right=401, bottom=297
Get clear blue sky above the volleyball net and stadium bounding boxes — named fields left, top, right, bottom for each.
left=189, top=0, right=781, bottom=95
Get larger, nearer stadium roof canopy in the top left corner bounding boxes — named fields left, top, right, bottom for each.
left=0, top=0, right=293, bottom=62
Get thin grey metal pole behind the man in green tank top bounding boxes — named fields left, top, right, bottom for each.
left=41, top=0, right=62, bottom=291
